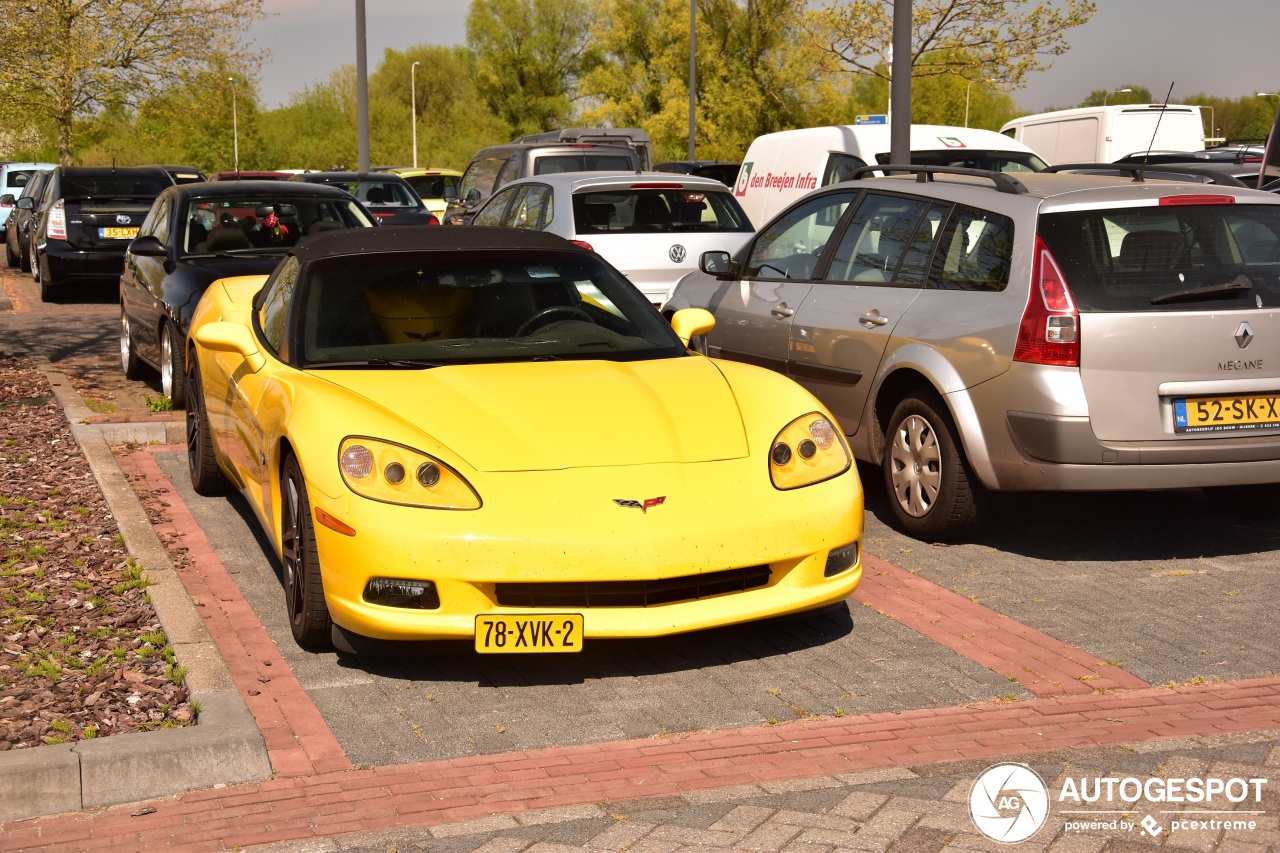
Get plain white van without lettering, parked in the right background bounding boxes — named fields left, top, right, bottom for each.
left=1000, top=104, right=1204, bottom=164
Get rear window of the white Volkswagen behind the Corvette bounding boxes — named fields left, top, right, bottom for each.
left=573, top=188, right=751, bottom=234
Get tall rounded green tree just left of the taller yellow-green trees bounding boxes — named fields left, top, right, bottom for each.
left=467, top=0, right=595, bottom=136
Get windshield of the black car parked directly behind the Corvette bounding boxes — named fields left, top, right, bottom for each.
left=179, top=195, right=374, bottom=255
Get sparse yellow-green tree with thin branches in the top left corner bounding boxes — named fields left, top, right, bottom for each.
left=0, top=0, right=262, bottom=165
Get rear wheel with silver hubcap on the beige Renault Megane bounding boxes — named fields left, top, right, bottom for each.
left=881, top=394, right=989, bottom=542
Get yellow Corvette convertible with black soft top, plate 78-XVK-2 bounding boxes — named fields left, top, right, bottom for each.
left=186, top=227, right=863, bottom=653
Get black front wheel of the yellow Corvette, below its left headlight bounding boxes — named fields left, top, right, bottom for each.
left=280, top=456, right=332, bottom=649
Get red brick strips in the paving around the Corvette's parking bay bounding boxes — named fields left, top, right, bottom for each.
left=0, top=448, right=1280, bottom=853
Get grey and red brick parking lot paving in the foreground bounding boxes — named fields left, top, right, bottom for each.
left=0, top=263, right=1280, bottom=853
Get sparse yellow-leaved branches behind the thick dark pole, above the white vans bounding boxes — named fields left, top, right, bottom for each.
left=806, top=0, right=1096, bottom=92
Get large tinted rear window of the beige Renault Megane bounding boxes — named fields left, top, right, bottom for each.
left=1039, top=204, right=1280, bottom=311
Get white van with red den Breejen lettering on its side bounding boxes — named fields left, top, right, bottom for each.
left=733, top=124, right=1047, bottom=228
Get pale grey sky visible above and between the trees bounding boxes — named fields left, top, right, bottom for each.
left=250, top=0, right=1280, bottom=113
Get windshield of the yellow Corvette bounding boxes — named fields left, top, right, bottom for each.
left=300, top=250, right=685, bottom=368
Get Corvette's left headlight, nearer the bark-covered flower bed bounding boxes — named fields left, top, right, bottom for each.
left=338, top=435, right=480, bottom=510
